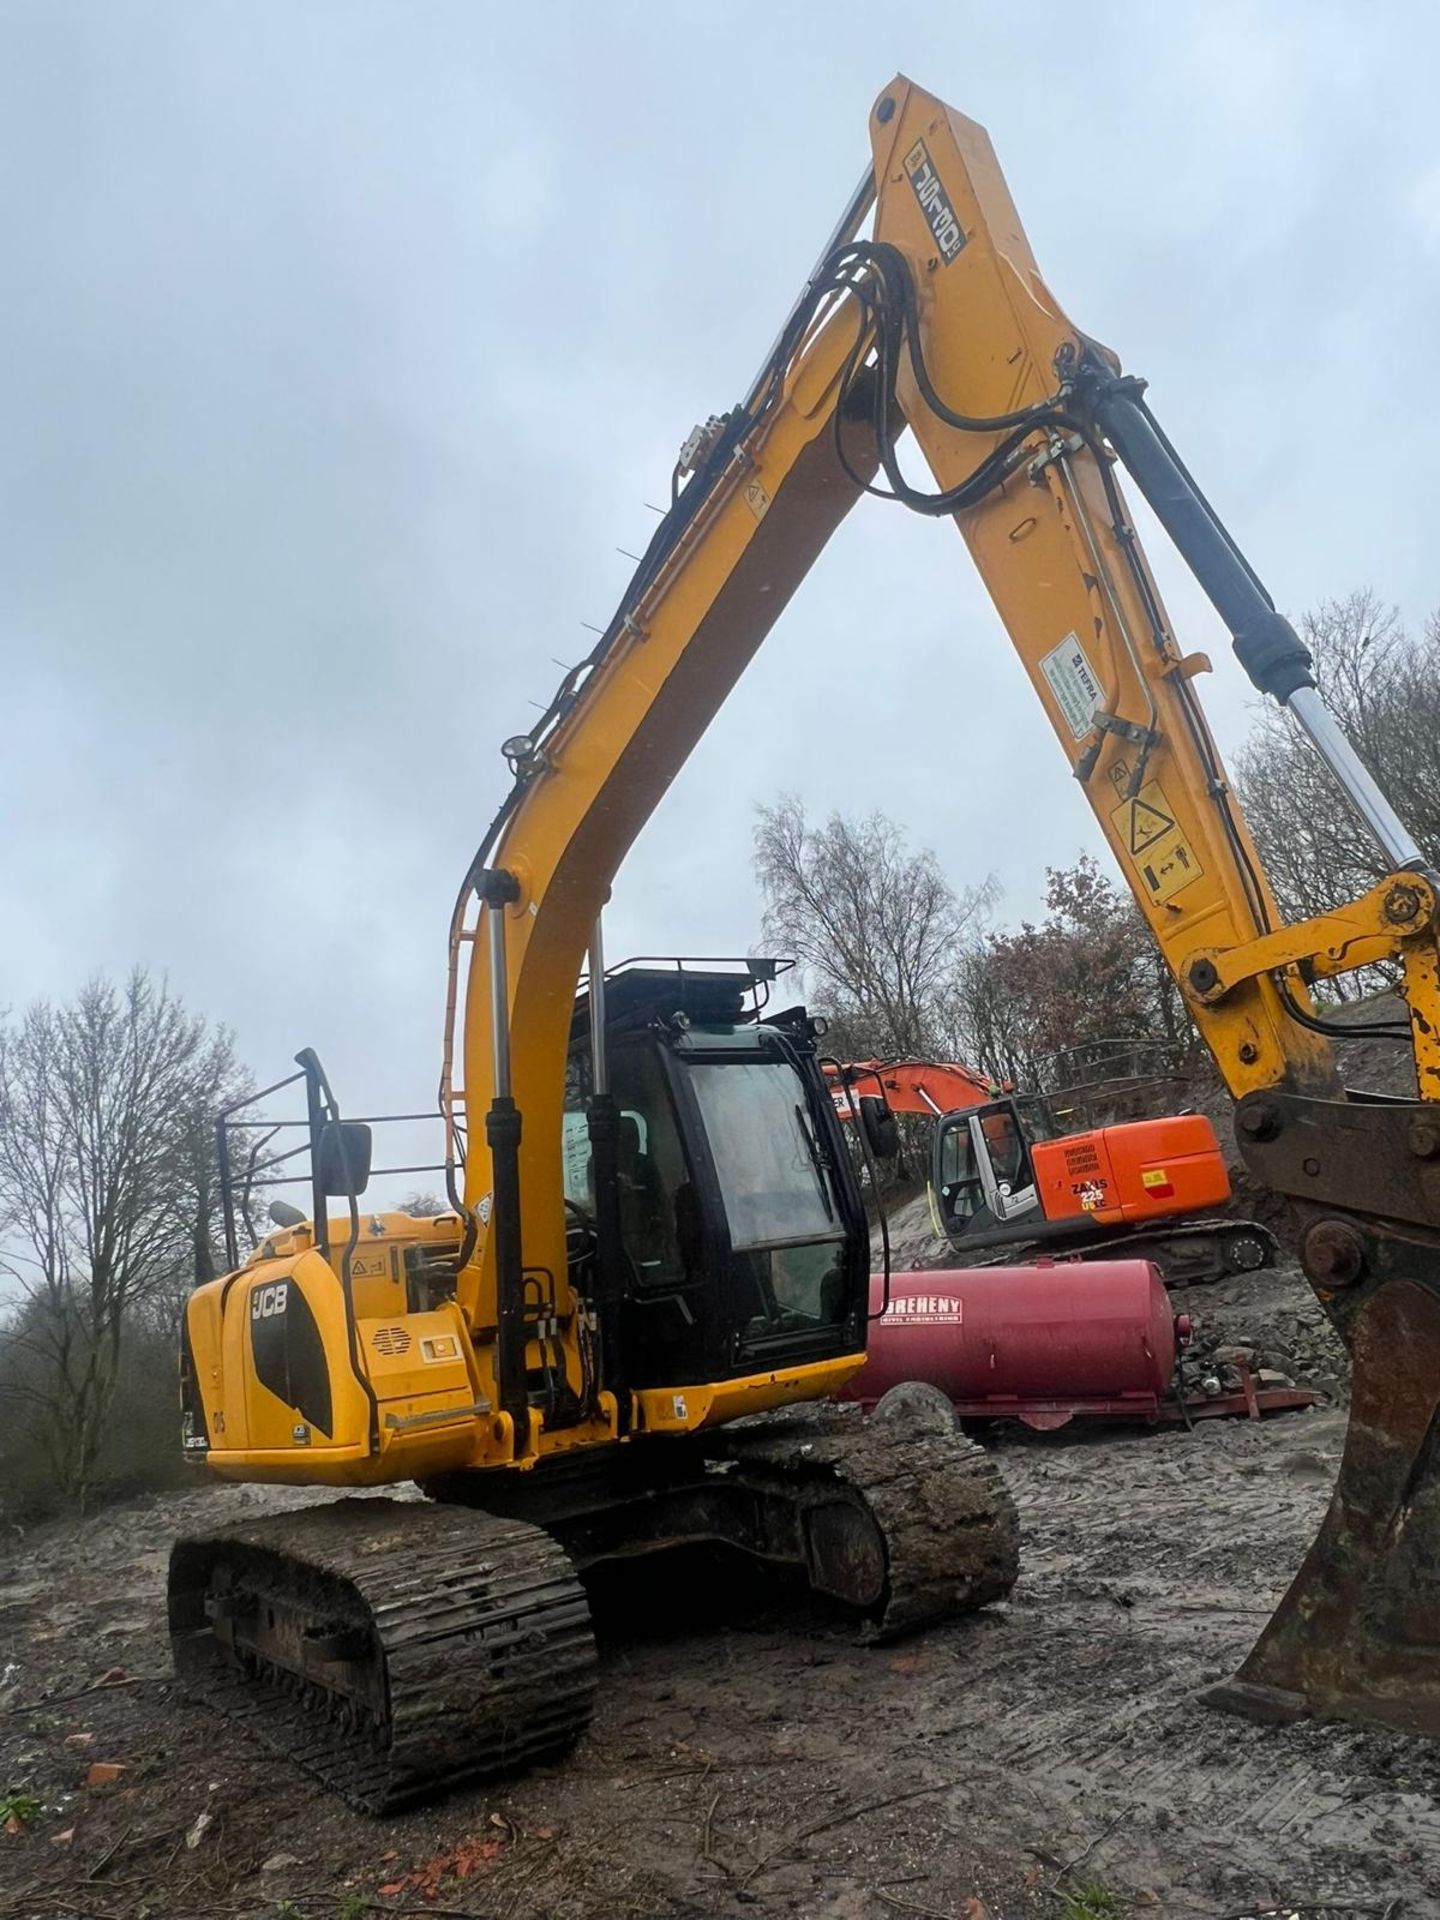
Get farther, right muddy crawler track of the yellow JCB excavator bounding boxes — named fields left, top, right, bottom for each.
left=710, top=1382, right=1020, bottom=1642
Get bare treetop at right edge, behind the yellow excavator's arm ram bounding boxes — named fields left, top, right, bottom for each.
left=1235, top=588, right=1440, bottom=960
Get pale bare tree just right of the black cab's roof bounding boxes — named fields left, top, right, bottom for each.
left=755, top=793, right=995, bottom=1056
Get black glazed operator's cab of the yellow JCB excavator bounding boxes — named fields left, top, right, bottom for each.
left=563, top=964, right=870, bottom=1386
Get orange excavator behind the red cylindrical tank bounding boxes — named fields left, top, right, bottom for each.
left=826, top=1060, right=1275, bottom=1284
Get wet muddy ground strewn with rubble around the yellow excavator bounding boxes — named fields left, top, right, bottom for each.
left=0, top=1271, right=1440, bottom=1920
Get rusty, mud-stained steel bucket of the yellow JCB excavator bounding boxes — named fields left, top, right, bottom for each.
left=1204, top=1246, right=1440, bottom=1740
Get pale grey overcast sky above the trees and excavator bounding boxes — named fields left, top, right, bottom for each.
left=0, top=0, right=1440, bottom=1152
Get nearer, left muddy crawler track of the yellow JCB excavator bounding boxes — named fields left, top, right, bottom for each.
left=169, top=1500, right=595, bottom=1812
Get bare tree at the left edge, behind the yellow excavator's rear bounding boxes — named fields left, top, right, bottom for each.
left=0, top=970, right=242, bottom=1501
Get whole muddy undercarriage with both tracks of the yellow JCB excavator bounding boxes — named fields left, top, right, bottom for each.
left=169, top=1382, right=1020, bottom=1812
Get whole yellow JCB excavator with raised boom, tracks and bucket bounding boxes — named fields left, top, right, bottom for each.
left=171, top=79, right=1440, bottom=1807
